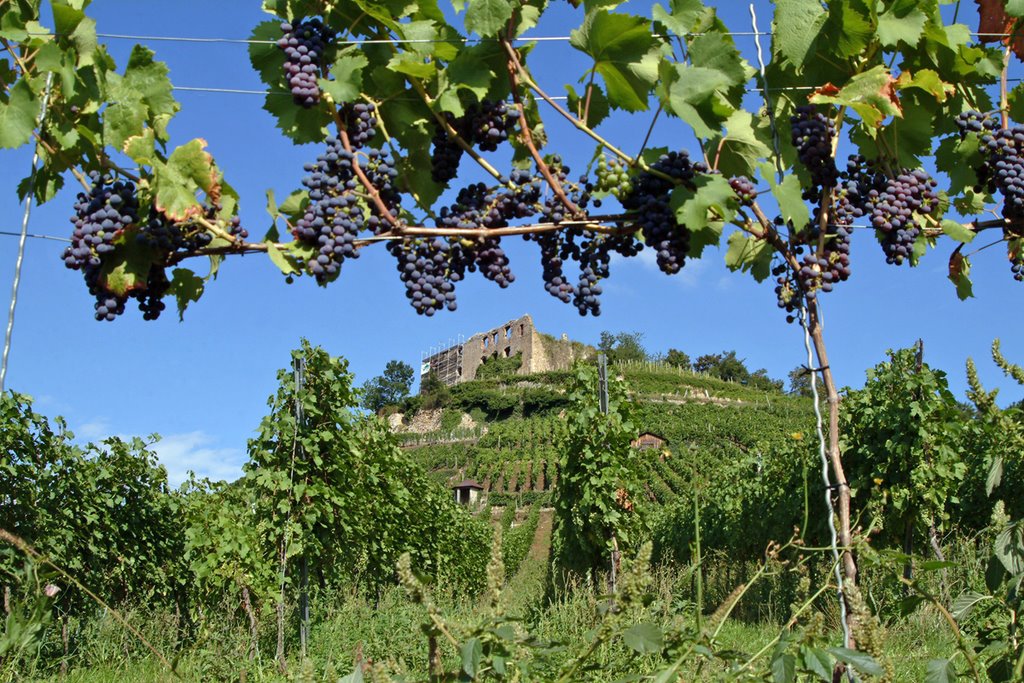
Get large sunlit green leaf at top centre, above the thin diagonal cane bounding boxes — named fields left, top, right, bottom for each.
left=569, top=9, right=659, bottom=112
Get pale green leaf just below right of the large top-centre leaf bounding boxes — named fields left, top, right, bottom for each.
left=662, top=63, right=734, bottom=137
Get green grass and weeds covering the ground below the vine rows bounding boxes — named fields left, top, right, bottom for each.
left=14, top=552, right=953, bottom=683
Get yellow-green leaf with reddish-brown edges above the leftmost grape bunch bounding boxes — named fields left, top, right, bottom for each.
left=153, top=138, right=219, bottom=220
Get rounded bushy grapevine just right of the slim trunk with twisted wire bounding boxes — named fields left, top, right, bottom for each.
left=842, top=349, right=967, bottom=538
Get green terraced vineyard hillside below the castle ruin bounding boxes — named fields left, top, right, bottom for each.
left=398, top=364, right=813, bottom=505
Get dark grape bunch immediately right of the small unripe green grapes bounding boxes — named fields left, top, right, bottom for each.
left=622, top=152, right=708, bottom=275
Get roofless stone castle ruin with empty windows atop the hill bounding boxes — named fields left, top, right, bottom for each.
left=420, top=314, right=594, bottom=386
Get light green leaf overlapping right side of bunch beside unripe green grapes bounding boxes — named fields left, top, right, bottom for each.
left=669, top=175, right=738, bottom=258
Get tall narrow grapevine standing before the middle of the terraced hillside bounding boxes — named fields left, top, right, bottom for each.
left=551, top=364, right=644, bottom=574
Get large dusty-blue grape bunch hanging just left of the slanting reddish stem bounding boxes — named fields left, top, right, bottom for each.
left=292, top=137, right=366, bottom=284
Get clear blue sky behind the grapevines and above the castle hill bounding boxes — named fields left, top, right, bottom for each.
left=0, top=0, right=1024, bottom=482
